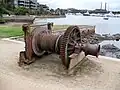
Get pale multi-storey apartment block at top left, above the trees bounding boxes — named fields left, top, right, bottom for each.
left=14, top=0, right=37, bottom=9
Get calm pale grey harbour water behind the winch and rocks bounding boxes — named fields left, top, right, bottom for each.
left=36, top=15, right=120, bottom=48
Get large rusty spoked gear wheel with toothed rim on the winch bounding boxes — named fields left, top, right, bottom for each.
left=60, top=26, right=81, bottom=68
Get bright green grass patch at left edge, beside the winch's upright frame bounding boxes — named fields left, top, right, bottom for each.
left=0, top=26, right=23, bottom=38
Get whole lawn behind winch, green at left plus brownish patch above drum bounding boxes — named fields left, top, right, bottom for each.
left=0, top=25, right=68, bottom=38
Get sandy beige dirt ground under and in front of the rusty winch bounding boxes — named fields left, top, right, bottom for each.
left=0, top=40, right=120, bottom=90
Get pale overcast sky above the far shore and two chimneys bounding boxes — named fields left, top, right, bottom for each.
left=38, top=0, right=120, bottom=10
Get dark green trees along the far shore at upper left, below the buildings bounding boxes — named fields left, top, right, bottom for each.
left=0, top=0, right=65, bottom=16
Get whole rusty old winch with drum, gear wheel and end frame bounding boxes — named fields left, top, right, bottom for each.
left=19, top=23, right=100, bottom=69
